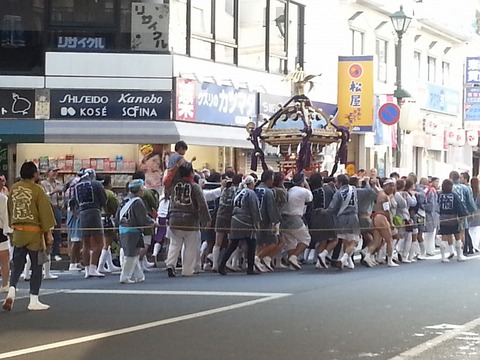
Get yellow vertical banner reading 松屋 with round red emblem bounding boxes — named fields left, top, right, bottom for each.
left=337, top=56, right=374, bottom=132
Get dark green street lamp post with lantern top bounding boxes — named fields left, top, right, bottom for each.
left=390, top=6, right=412, bottom=168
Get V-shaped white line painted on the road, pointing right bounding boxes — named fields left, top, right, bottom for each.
left=0, top=290, right=292, bottom=359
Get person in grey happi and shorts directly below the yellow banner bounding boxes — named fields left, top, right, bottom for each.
left=327, top=175, right=360, bottom=269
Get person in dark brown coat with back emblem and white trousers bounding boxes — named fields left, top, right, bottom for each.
left=166, top=161, right=211, bottom=277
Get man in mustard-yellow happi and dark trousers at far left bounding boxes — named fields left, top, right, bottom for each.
left=3, top=161, right=55, bottom=311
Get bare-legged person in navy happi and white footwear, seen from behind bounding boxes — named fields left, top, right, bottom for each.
left=74, top=169, right=107, bottom=278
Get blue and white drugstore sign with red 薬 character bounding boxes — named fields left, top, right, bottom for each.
left=175, top=78, right=257, bottom=126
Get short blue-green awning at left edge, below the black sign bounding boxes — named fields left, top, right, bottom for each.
left=0, top=119, right=44, bottom=144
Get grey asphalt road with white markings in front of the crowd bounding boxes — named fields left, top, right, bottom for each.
left=0, top=256, right=480, bottom=360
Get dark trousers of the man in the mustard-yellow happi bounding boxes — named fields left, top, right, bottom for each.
left=10, top=246, right=42, bottom=295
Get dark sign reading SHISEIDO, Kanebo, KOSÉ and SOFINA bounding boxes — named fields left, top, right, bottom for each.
left=50, top=90, right=171, bottom=120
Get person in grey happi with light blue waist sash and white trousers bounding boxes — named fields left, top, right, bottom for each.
left=115, top=179, right=158, bottom=284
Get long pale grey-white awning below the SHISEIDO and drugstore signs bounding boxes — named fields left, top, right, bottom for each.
left=45, top=120, right=251, bottom=148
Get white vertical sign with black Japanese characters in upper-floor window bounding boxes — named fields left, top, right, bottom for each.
left=131, top=2, right=169, bottom=51
